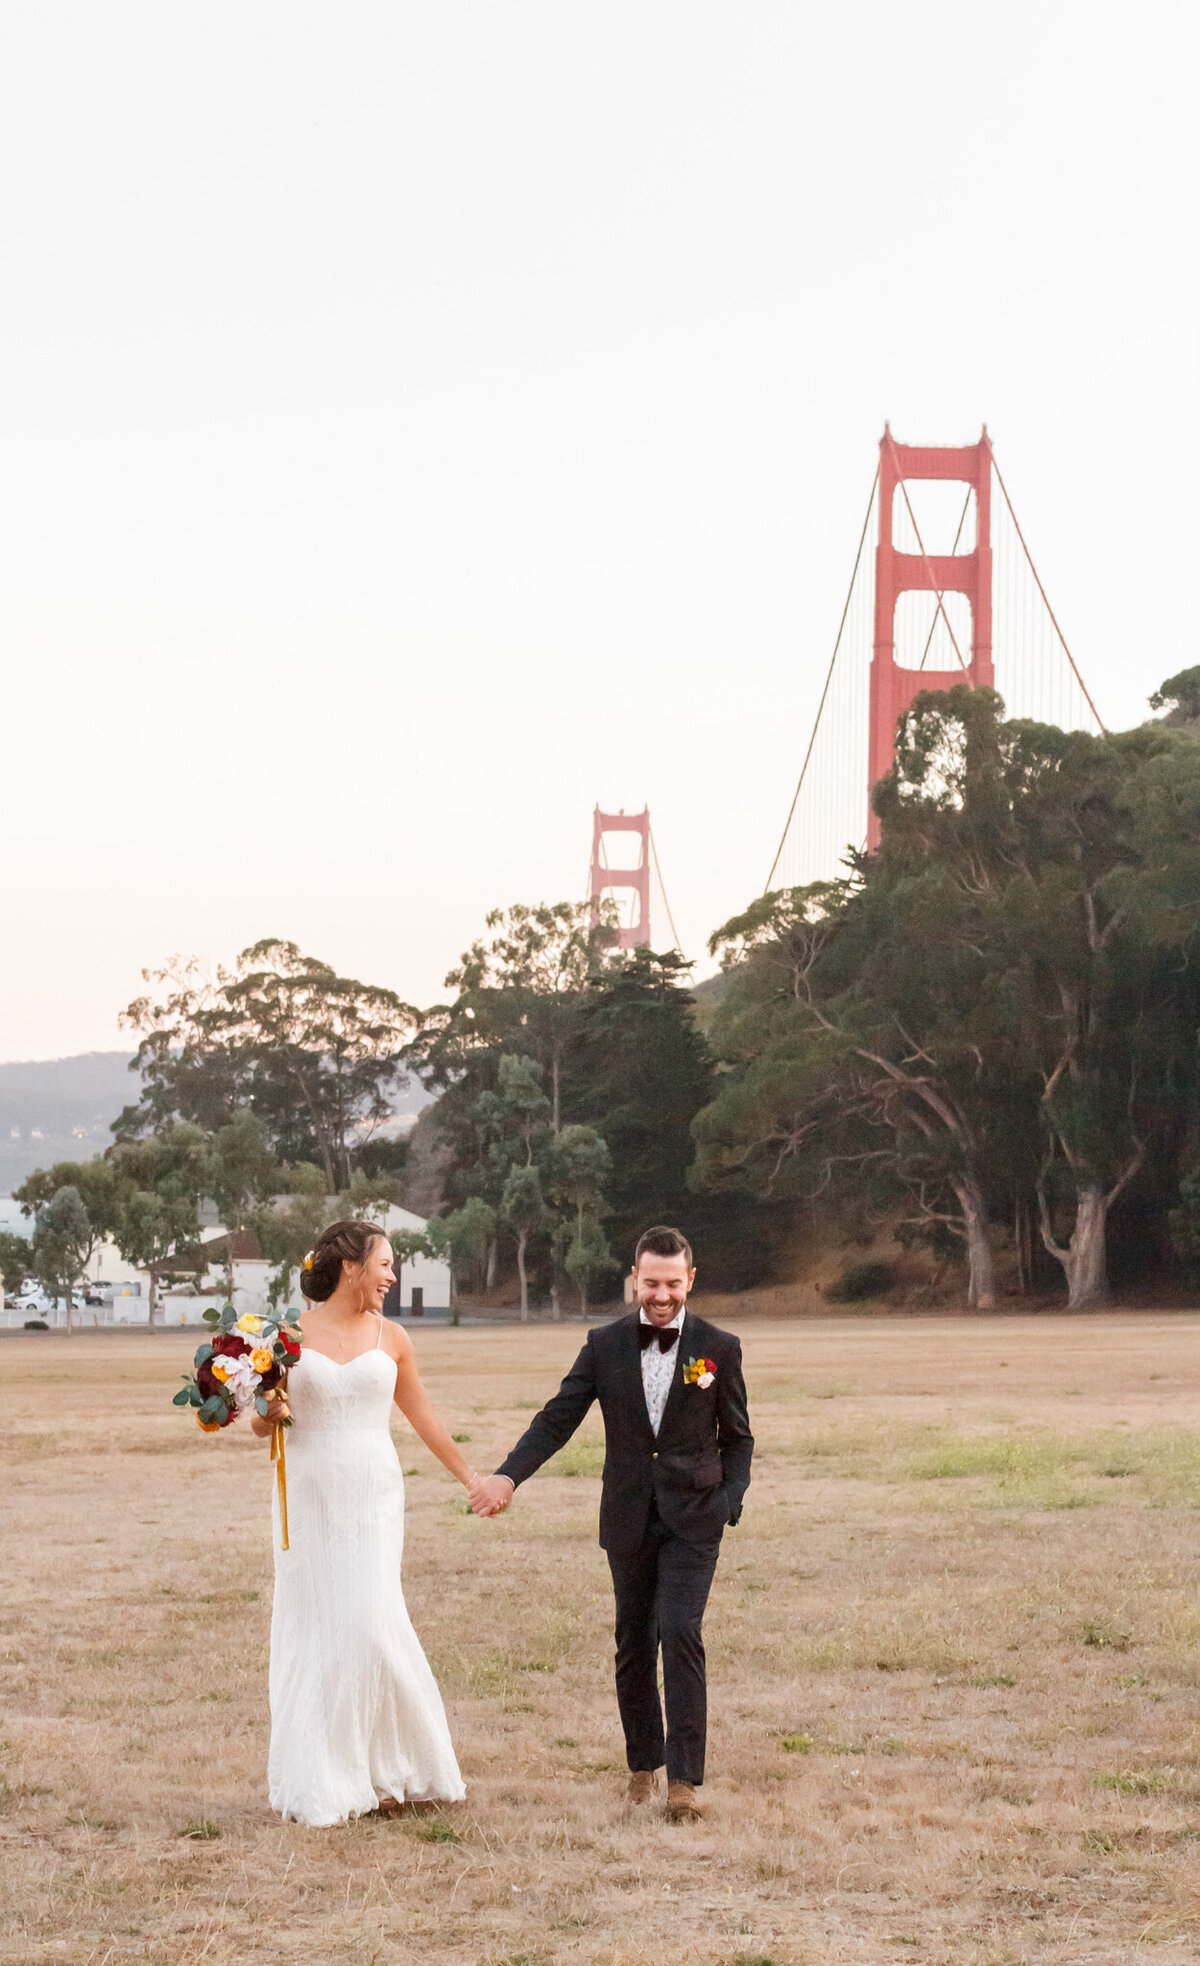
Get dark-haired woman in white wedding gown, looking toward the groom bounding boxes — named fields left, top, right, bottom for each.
left=252, top=1221, right=478, bottom=1828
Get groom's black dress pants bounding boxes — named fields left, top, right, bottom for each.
left=608, top=1512, right=720, bottom=1787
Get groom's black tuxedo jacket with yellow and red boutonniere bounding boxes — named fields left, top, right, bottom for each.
left=496, top=1311, right=753, bottom=1555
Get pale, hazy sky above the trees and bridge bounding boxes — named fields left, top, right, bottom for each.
left=0, top=0, right=1200, bottom=1058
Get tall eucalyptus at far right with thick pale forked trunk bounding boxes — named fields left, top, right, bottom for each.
left=875, top=688, right=1200, bottom=1307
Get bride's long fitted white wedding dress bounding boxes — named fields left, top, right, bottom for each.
left=268, top=1323, right=466, bottom=1828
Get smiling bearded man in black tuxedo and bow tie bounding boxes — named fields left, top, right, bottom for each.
left=472, top=1229, right=753, bottom=1822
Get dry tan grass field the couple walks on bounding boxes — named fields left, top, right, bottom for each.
left=0, top=1311, right=1200, bottom=1966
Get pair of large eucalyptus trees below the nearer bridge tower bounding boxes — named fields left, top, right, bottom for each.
left=694, top=686, right=1200, bottom=1305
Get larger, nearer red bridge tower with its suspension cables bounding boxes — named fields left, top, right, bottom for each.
left=767, top=427, right=1104, bottom=889
